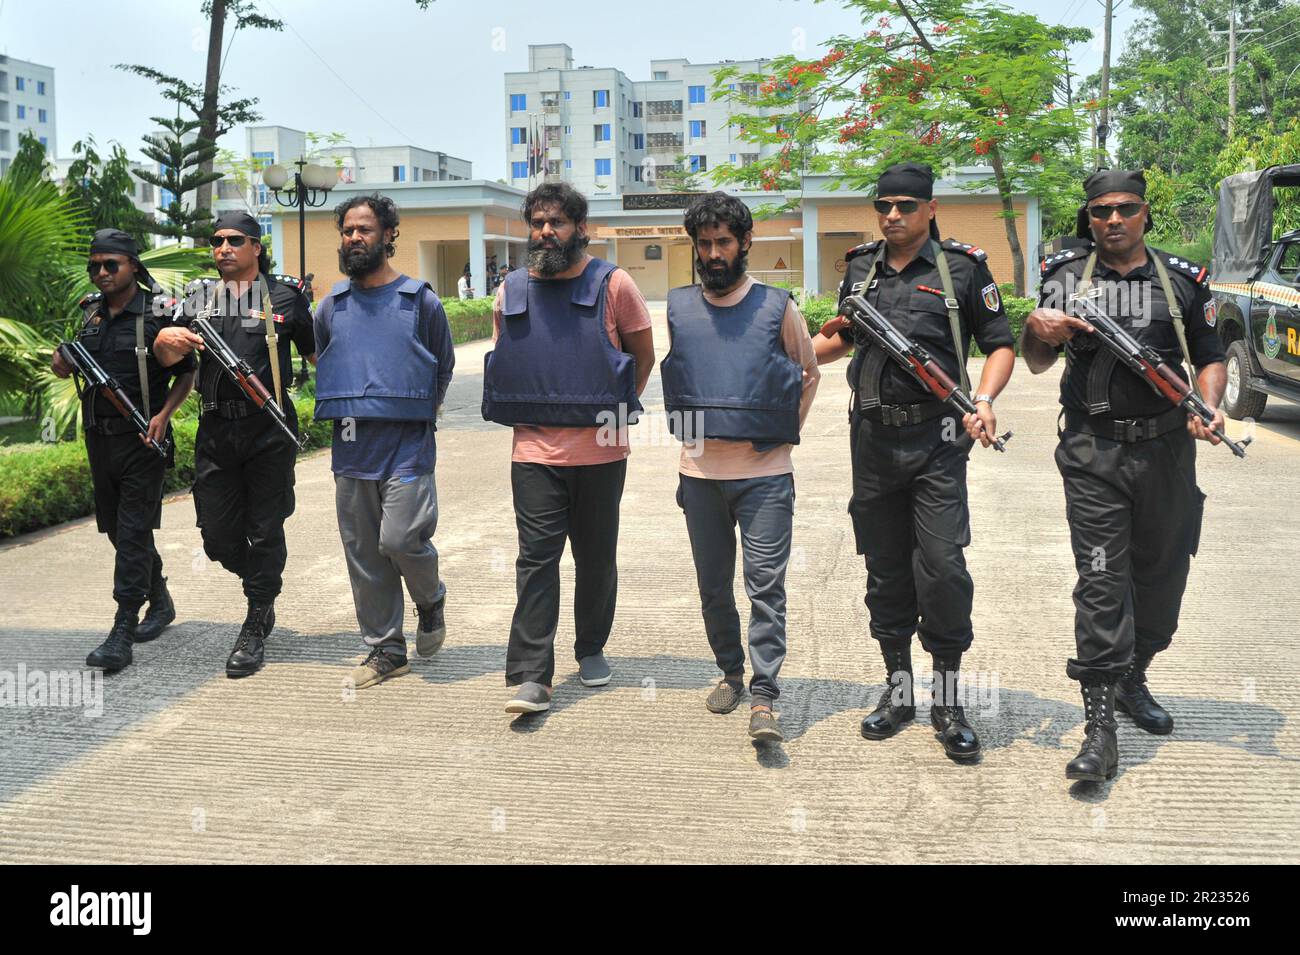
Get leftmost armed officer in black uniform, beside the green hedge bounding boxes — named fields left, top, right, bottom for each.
left=52, top=229, right=194, bottom=670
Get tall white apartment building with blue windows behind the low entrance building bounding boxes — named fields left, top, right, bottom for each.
left=504, top=43, right=776, bottom=196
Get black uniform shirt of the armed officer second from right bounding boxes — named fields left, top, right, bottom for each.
left=840, top=239, right=1014, bottom=404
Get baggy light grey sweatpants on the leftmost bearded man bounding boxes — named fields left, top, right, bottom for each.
left=334, top=472, right=446, bottom=656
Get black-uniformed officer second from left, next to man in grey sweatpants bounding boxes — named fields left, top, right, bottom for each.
left=150, top=212, right=316, bottom=677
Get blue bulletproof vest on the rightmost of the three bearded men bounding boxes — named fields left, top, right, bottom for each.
left=659, top=283, right=803, bottom=451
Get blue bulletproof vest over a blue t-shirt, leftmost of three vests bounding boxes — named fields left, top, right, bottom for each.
left=316, top=278, right=438, bottom=421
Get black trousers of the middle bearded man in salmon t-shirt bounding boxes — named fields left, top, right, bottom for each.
left=506, top=459, right=628, bottom=686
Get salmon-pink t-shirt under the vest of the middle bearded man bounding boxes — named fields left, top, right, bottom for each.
left=491, top=256, right=650, bottom=468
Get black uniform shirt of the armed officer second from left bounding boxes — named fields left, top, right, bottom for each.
left=177, top=275, right=316, bottom=402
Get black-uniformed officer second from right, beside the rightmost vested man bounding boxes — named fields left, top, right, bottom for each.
left=814, top=162, right=1015, bottom=760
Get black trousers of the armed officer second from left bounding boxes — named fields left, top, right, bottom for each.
left=194, top=412, right=298, bottom=603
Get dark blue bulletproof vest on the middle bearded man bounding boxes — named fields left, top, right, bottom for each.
left=482, top=259, right=641, bottom=427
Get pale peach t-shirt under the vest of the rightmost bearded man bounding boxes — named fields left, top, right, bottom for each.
left=677, top=275, right=822, bottom=481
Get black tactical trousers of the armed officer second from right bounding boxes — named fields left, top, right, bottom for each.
left=849, top=412, right=975, bottom=654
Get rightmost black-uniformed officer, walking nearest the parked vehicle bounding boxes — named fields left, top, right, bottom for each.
left=1023, top=169, right=1226, bottom=782
